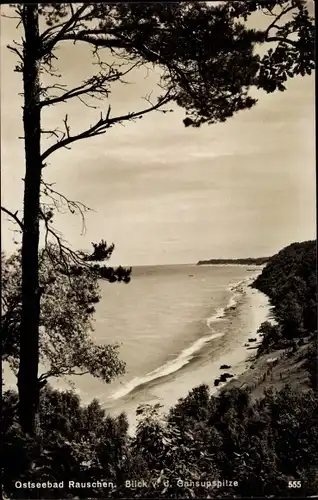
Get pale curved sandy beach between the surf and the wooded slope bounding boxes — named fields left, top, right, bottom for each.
left=112, top=270, right=270, bottom=435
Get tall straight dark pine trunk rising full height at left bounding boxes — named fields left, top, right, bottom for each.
left=18, top=4, right=41, bottom=435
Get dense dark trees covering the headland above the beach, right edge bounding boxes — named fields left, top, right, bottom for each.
left=253, top=241, right=317, bottom=364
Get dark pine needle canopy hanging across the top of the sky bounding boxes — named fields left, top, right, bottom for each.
left=31, top=0, right=315, bottom=127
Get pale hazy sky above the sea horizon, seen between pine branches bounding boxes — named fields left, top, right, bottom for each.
left=0, top=2, right=316, bottom=265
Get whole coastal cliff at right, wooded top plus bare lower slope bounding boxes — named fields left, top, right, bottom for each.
left=222, top=241, right=317, bottom=399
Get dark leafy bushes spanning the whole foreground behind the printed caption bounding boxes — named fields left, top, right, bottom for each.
left=2, top=385, right=318, bottom=498
